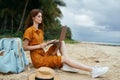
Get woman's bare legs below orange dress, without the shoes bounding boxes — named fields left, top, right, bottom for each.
left=60, top=41, right=92, bottom=72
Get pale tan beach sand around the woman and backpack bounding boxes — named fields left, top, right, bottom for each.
left=0, top=43, right=120, bottom=80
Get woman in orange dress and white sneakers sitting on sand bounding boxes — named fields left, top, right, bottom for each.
left=23, top=9, right=108, bottom=77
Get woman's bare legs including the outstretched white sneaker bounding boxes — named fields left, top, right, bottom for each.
left=60, top=41, right=109, bottom=78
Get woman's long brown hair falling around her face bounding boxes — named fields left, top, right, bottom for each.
left=25, top=9, right=44, bottom=31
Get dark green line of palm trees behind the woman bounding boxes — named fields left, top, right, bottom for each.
left=0, top=0, right=72, bottom=40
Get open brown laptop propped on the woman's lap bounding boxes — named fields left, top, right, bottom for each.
left=53, top=26, right=67, bottom=54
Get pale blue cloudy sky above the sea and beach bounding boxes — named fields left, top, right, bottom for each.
left=60, top=0, right=120, bottom=42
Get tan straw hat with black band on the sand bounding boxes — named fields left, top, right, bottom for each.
left=29, top=67, right=60, bottom=80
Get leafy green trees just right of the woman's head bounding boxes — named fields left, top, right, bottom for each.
left=39, top=0, right=66, bottom=39
